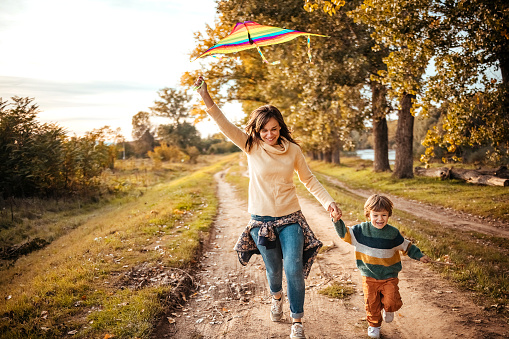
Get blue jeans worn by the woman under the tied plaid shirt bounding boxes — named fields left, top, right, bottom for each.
left=250, top=215, right=306, bottom=319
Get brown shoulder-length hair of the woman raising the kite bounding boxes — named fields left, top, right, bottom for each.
left=245, top=105, right=298, bottom=152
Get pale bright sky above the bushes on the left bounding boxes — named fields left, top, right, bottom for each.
left=0, top=0, right=240, bottom=140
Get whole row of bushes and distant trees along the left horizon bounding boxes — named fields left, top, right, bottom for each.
left=0, top=94, right=238, bottom=200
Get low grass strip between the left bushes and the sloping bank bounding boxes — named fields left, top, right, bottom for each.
left=0, top=159, right=198, bottom=252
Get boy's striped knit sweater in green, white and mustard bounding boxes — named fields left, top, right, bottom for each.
left=334, top=220, right=424, bottom=280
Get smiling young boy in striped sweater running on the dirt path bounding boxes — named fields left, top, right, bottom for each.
left=334, top=194, right=430, bottom=338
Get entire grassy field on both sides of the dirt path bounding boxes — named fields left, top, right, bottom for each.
left=0, top=154, right=509, bottom=338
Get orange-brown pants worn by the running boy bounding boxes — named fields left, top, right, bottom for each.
left=362, top=276, right=403, bottom=327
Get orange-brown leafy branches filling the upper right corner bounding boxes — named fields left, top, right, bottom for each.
left=304, top=0, right=509, bottom=166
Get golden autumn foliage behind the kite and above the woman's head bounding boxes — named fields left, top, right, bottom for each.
left=182, top=0, right=381, bottom=163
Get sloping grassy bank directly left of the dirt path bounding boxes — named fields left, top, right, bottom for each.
left=0, top=156, right=238, bottom=338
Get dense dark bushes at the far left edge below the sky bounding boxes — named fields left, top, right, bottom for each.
left=0, top=97, right=122, bottom=199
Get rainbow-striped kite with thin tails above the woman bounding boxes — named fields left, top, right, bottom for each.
left=190, top=21, right=327, bottom=64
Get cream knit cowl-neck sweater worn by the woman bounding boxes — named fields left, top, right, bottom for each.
left=207, top=104, right=334, bottom=217
